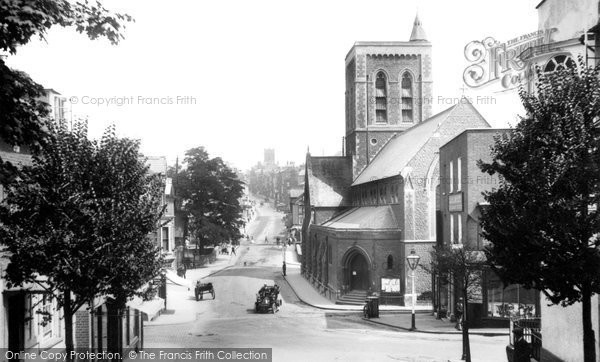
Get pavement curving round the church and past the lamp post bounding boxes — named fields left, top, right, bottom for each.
left=284, top=250, right=509, bottom=337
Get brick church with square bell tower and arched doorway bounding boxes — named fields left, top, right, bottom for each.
left=302, top=16, right=490, bottom=305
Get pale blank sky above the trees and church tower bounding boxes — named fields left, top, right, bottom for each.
left=7, top=0, right=539, bottom=169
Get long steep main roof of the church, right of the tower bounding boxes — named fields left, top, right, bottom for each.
left=352, top=98, right=489, bottom=186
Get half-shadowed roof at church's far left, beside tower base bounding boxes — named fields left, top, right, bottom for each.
left=306, top=154, right=352, bottom=207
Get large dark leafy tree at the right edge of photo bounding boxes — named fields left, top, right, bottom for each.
left=480, top=59, right=600, bottom=361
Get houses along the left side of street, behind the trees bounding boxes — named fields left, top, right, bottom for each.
left=0, top=89, right=175, bottom=352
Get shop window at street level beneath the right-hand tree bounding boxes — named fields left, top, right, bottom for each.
left=485, top=270, right=538, bottom=318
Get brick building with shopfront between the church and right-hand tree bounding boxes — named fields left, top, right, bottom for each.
left=435, top=129, right=540, bottom=327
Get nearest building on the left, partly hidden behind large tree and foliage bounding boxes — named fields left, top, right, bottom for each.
left=0, top=89, right=163, bottom=352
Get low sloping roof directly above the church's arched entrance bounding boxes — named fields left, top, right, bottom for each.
left=323, top=205, right=400, bottom=230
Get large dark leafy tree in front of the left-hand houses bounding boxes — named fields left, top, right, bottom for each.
left=0, top=122, right=162, bottom=352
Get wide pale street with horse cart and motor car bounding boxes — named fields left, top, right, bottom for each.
left=144, top=204, right=506, bottom=362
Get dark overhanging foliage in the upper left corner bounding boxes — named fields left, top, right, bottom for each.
left=0, top=0, right=132, bottom=185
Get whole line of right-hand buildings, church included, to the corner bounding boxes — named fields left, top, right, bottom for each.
left=290, top=0, right=600, bottom=361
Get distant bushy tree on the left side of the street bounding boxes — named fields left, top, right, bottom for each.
left=177, top=147, right=244, bottom=255
